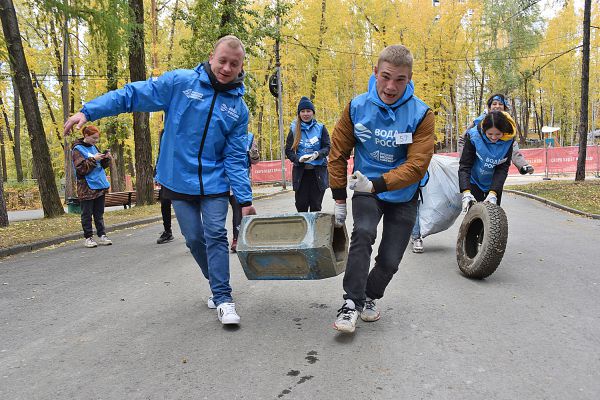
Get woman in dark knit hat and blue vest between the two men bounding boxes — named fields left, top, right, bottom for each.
left=285, top=97, right=331, bottom=212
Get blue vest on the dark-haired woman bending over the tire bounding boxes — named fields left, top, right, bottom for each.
left=468, top=127, right=514, bottom=192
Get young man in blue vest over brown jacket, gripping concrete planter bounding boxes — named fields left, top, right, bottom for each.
left=329, top=45, right=435, bottom=333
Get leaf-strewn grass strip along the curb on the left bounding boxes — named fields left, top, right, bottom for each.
left=0, top=203, right=160, bottom=249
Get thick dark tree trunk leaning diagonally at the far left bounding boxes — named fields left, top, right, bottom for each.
left=0, top=0, right=65, bottom=217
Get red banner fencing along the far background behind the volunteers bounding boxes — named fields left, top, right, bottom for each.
left=252, top=146, right=600, bottom=183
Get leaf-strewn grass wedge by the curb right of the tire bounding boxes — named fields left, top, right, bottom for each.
left=505, top=177, right=600, bottom=215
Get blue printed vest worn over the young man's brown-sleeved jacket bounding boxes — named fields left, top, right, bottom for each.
left=350, top=81, right=429, bottom=203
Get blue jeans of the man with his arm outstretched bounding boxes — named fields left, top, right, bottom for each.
left=173, top=196, right=233, bottom=306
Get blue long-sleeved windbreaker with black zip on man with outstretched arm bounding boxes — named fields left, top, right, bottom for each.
left=81, top=64, right=252, bottom=204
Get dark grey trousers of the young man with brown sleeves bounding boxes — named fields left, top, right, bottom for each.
left=344, top=193, right=418, bottom=310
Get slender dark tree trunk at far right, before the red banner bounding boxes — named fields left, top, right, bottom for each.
left=575, top=0, right=592, bottom=181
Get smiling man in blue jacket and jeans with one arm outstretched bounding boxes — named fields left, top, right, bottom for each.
left=64, top=35, right=255, bottom=324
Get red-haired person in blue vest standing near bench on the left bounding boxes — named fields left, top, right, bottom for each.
left=71, top=125, right=112, bottom=247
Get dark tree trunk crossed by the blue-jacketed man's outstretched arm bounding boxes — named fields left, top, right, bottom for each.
left=129, top=0, right=154, bottom=205
